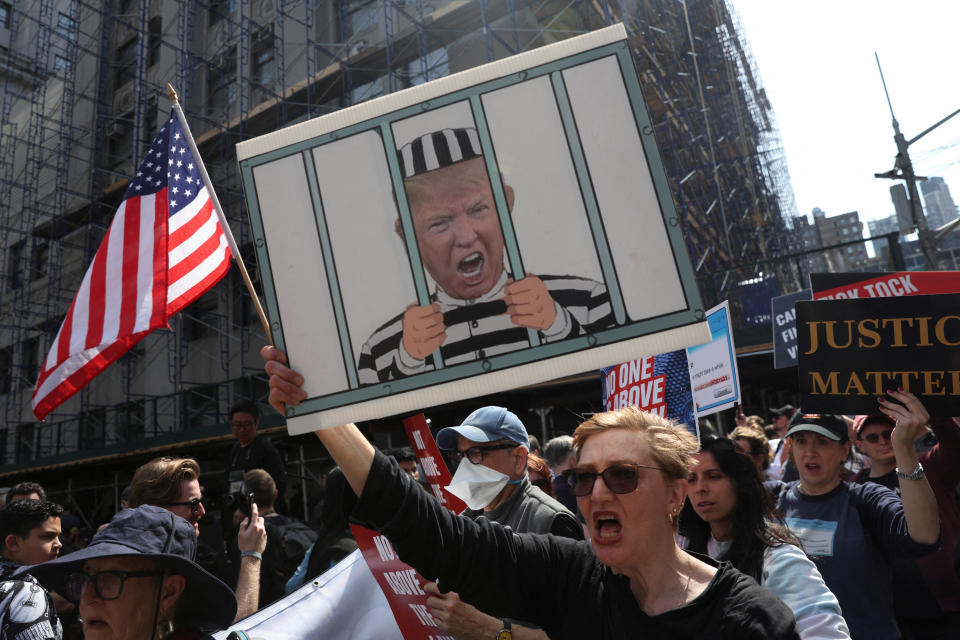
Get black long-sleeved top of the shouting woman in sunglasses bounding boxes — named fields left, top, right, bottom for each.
left=345, top=452, right=798, bottom=640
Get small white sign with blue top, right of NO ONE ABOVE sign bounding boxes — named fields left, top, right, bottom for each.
left=687, top=300, right=740, bottom=416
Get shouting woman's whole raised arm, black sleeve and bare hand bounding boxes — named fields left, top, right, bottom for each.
left=260, top=347, right=584, bottom=637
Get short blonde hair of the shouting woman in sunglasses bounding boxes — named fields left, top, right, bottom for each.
left=573, top=407, right=700, bottom=480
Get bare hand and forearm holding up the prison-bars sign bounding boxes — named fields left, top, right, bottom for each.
left=260, top=345, right=374, bottom=495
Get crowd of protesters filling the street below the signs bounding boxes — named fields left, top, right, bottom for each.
left=0, top=348, right=960, bottom=640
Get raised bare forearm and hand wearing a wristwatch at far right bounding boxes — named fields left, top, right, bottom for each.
left=880, top=391, right=940, bottom=544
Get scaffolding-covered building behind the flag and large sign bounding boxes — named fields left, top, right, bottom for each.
left=0, top=0, right=796, bottom=465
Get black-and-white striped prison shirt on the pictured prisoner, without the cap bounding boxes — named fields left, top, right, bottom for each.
left=358, top=272, right=615, bottom=385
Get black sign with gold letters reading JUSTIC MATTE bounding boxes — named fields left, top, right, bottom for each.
left=797, top=294, right=960, bottom=416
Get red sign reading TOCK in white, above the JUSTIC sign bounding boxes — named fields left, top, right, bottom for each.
left=810, top=271, right=960, bottom=300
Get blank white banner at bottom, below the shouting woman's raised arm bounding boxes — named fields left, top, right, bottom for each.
left=212, top=550, right=404, bottom=640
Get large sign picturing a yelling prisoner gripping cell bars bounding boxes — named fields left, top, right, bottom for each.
left=237, top=25, right=709, bottom=433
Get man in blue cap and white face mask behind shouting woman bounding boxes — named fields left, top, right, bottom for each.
left=426, top=407, right=583, bottom=640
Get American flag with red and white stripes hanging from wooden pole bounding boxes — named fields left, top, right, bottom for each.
left=33, top=114, right=230, bottom=420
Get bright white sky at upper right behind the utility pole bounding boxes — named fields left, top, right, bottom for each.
left=733, top=0, right=960, bottom=228
